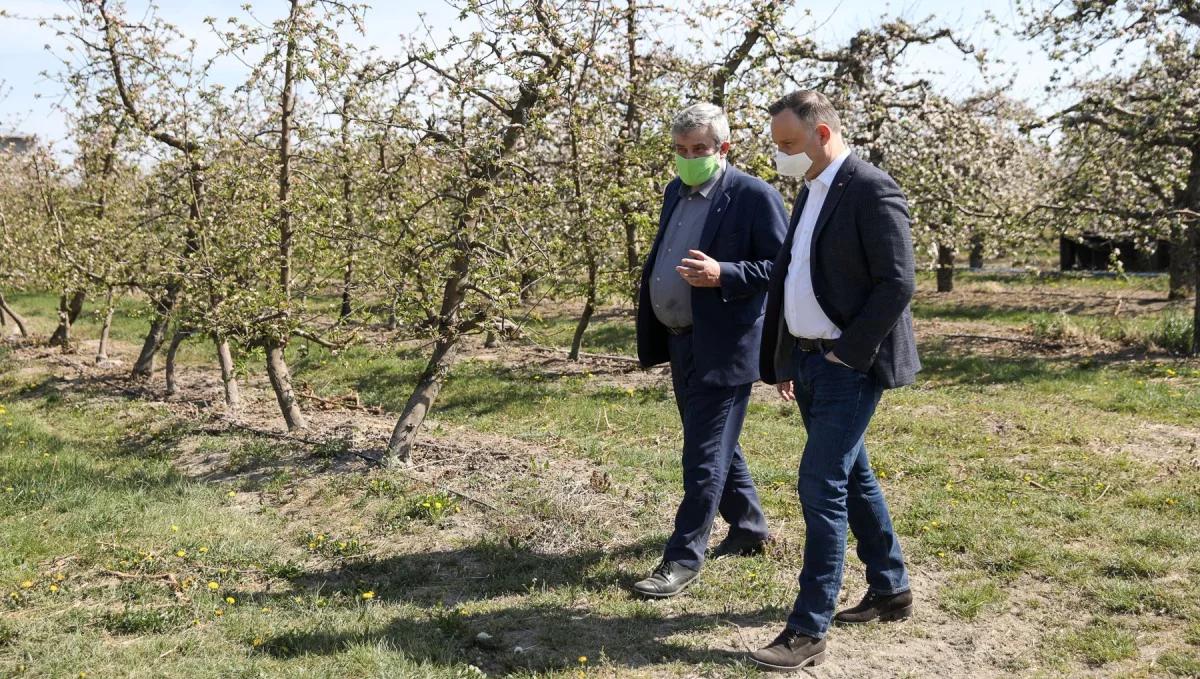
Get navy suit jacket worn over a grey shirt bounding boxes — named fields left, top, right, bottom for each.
left=637, top=164, right=787, bottom=386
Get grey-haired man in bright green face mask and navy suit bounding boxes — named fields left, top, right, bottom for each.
left=634, top=103, right=786, bottom=597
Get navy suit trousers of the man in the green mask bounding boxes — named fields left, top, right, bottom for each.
left=662, top=334, right=767, bottom=570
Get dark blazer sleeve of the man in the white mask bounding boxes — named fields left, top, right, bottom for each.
left=833, top=176, right=917, bottom=372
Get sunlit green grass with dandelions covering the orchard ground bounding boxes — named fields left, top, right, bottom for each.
left=0, top=280, right=1200, bottom=677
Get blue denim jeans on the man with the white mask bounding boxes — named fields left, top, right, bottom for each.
left=787, top=350, right=908, bottom=638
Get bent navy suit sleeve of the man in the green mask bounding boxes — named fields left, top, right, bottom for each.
left=721, top=184, right=787, bottom=301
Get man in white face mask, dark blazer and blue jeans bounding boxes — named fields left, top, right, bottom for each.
left=750, top=91, right=920, bottom=669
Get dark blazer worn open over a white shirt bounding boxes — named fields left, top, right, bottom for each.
left=761, top=154, right=920, bottom=389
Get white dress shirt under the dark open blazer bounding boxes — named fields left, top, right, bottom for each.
left=784, top=149, right=850, bottom=340
